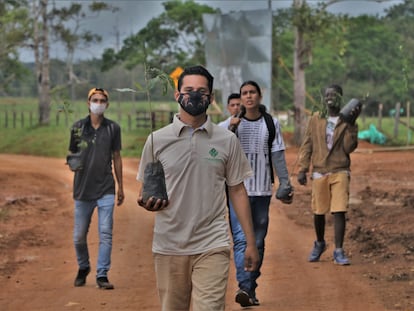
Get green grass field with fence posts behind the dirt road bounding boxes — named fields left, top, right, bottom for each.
left=0, top=98, right=414, bottom=157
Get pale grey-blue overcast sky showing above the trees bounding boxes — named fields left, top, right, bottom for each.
left=21, top=0, right=403, bottom=60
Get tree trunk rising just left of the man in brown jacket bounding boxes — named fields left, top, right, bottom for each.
left=293, top=0, right=306, bottom=146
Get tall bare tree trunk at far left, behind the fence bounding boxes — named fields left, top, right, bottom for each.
left=37, top=0, right=50, bottom=125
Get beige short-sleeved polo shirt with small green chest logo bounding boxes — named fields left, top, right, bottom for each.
left=137, top=115, right=253, bottom=255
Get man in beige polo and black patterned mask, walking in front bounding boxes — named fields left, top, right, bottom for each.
left=137, top=66, right=259, bottom=311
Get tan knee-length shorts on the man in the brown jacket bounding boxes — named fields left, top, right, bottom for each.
left=312, top=172, right=350, bottom=215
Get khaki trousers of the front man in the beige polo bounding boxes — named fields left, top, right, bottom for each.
left=153, top=247, right=230, bottom=311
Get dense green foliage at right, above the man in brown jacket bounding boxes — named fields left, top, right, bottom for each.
left=273, top=0, right=414, bottom=114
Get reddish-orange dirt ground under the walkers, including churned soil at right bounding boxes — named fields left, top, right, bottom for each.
left=0, top=142, right=414, bottom=311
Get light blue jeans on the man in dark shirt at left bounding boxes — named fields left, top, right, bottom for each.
left=73, top=194, right=115, bottom=278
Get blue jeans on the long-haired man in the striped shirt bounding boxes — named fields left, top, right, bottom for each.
left=229, top=196, right=271, bottom=298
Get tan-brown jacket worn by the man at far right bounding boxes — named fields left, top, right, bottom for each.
left=298, top=113, right=358, bottom=174
